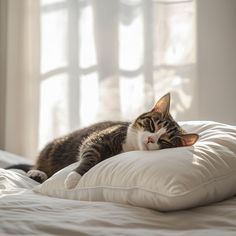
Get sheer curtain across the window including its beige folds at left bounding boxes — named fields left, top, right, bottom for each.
left=1, top=0, right=197, bottom=157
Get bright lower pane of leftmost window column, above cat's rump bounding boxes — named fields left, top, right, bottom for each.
left=39, top=74, right=69, bottom=148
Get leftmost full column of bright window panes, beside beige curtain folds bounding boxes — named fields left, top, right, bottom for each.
left=39, top=0, right=70, bottom=149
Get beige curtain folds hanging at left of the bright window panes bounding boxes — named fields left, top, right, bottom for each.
left=0, top=0, right=40, bottom=158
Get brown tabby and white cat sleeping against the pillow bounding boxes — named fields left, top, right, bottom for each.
left=24, top=93, right=198, bottom=189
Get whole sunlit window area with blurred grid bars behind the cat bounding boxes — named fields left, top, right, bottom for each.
left=39, top=0, right=197, bottom=150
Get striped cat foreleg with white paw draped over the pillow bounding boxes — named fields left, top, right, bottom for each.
left=64, top=149, right=101, bottom=189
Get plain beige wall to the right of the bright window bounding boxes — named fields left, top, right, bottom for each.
left=196, top=0, right=236, bottom=125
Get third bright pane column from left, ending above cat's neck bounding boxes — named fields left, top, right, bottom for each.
left=119, top=1, right=145, bottom=120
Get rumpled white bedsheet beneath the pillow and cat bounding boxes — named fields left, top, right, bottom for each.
left=0, top=151, right=236, bottom=236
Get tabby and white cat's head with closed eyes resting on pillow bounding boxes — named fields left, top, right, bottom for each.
left=127, top=93, right=199, bottom=150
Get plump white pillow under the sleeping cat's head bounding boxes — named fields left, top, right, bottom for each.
left=34, top=121, right=236, bottom=211
